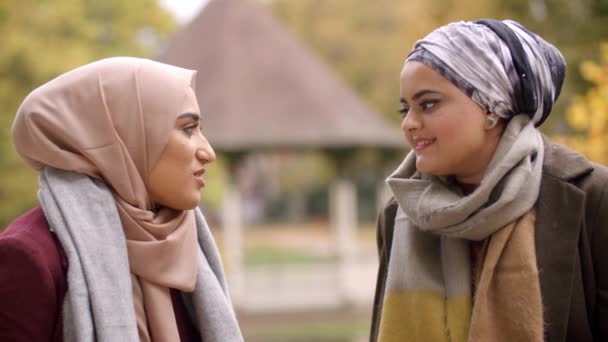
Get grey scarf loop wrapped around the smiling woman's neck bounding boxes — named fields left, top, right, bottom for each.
left=387, top=114, right=543, bottom=240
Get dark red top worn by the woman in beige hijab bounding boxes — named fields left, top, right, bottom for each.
left=0, top=207, right=201, bottom=342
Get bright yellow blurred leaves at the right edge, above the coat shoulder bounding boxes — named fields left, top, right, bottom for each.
left=557, top=43, right=608, bottom=165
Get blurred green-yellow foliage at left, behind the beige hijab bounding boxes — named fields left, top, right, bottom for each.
left=0, top=0, right=175, bottom=230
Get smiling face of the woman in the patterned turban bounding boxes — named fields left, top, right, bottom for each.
left=401, top=61, right=500, bottom=184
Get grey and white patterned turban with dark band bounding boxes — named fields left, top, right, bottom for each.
left=406, top=19, right=566, bottom=127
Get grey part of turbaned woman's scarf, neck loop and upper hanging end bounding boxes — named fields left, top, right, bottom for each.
left=386, top=115, right=543, bottom=316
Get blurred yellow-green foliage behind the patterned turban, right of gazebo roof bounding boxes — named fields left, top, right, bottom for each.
left=266, top=0, right=608, bottom=131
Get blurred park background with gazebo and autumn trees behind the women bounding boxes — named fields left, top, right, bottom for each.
left=0, top=0, right=608, bottom=341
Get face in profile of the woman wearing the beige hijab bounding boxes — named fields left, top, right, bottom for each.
left=148, top=89, right=215, bottom=210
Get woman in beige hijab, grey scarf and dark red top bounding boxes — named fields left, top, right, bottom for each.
left=0, top=57, right=242, bottom=341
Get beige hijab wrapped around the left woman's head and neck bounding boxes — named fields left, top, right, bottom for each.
left=12, top=57, right=198, bottom=341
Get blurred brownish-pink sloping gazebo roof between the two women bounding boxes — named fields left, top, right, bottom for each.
left=158, top=0, right=404, bottom=151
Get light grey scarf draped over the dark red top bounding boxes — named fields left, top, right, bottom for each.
left=38, top=167, right=243, bottom=342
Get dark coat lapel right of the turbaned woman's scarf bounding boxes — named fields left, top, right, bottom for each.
left=535, top=137, right=593, bottom=341
